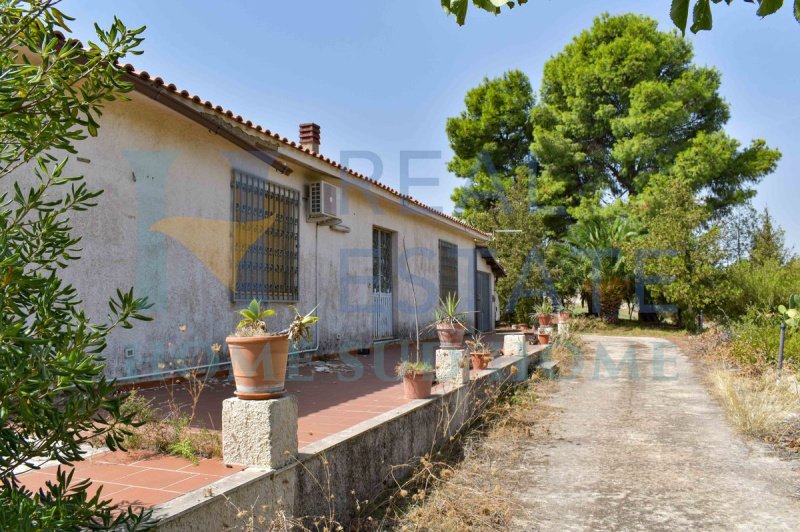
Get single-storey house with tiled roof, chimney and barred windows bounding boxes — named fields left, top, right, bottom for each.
left=12, top=65, right=503, bottom=379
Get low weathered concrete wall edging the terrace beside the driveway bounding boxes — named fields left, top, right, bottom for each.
left=153, top=344, right=538, bottom=531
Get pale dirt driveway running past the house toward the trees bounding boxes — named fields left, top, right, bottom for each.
left=515, top=336, right=800, bottom=531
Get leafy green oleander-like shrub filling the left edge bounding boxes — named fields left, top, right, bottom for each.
left=0, top=0, right=147, bottom=530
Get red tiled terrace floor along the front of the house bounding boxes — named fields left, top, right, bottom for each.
left=20, top=337, right=536, bottom=507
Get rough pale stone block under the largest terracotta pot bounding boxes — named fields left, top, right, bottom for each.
left=222, top=395, right=297, bottom=469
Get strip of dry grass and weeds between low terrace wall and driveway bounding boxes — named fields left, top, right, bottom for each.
left=370, top=375, right=557, bottom=531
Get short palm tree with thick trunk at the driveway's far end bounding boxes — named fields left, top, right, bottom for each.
left=565, top=217, right=637, bottom=323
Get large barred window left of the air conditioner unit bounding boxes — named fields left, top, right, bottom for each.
left=231, top=170, right=300, bottom=301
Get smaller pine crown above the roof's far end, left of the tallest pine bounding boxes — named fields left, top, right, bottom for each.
left=446, top=70, right=535, bottom=222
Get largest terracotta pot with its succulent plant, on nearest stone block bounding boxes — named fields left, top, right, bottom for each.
left=225, top=299, right=319, bottom=400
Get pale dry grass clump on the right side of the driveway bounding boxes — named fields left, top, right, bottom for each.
left=709, top=368, right=800, bottom=438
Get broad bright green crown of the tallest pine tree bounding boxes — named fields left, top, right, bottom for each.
left=533, top=15, right=780, bottom=224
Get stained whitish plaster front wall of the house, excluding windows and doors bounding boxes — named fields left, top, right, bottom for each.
left=3, top=93, right=490, bottom=378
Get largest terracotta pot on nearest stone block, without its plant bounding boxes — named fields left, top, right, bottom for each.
left=225, top=335, right=289, bottom=399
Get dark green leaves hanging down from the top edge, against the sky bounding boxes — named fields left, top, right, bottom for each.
left=442, top=0, right=800, bottom=33
